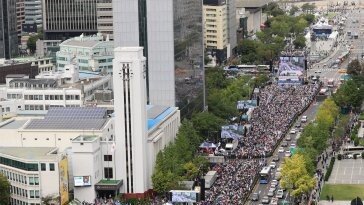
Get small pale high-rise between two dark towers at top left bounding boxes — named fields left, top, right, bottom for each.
left=24, top=0, right=43, bottom=27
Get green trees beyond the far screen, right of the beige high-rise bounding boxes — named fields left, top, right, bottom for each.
left=237, top=2, right=315, bottom=64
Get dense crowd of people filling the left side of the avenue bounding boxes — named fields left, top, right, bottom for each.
left=199, top=84, right=319, bottom=205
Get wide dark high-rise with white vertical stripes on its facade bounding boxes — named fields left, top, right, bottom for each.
left=42, top=0, right=97, bottom=40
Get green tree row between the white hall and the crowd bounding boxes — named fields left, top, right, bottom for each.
left=152, top=68, right=268, bottom=194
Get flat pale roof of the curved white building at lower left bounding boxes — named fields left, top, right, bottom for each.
left=0, top=147, right=57, bottom=161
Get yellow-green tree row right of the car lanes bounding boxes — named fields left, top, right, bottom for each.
left=280, top=98, right=339, bottom=198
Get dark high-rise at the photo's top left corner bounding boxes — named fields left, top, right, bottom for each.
left=0, top=0, right=18, bottom=59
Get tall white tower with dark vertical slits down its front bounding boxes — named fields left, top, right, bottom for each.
left=113, top=47, right=151, bottom=193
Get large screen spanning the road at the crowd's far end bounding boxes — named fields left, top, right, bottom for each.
left=278, top=56, right=305, bottom=76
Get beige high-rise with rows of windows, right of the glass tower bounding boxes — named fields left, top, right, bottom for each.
left=203, top=0, right=229, bottom=61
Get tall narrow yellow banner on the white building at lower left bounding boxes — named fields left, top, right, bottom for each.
left=58, top=156, right=69, bottom=205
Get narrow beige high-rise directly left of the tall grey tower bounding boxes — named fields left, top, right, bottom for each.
left=96, top=0, right=114, bottom=40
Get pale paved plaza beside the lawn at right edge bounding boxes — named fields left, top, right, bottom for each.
left=328, top=159, right=364, bottom=184
